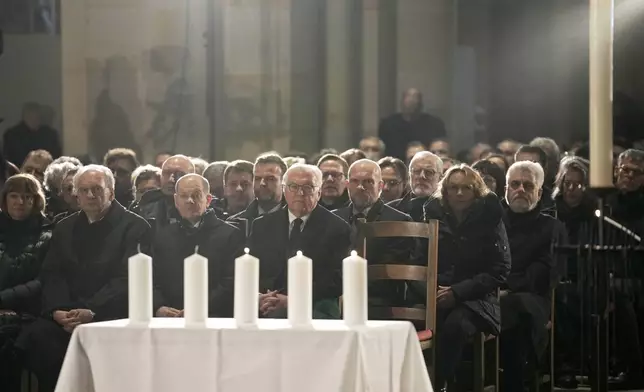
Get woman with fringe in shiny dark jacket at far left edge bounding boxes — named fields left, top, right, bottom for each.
left=0, top=174, right=51, bottom=391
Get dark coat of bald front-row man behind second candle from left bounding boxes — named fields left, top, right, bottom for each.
left=152, top=209, right=245, bottom=317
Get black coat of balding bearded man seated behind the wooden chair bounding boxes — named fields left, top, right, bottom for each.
left=333, top=199, right=420, bottom=306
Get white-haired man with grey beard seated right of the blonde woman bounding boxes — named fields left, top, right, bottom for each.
left=501, top=161, right=563, bottom=391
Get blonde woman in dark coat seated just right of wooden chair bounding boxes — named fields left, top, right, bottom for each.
left=424, top=165, right=510, bottom=390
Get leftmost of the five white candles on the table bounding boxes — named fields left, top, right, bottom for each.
left=127, top=247, right=152, bottom=323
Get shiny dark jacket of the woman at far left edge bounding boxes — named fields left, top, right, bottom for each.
left=0, top=213, right=52, bottom=315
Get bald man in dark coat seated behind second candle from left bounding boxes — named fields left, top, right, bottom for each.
left=152, top=174, right=245, bottom=317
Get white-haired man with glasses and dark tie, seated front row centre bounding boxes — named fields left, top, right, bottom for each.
left=249, top=164, right=351, bottom=317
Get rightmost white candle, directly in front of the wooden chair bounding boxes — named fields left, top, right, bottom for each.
left=342, top=251, right=368, bottom=326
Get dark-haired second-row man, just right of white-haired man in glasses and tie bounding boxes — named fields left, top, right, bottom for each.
left=318, top=154, right=349, bottom=211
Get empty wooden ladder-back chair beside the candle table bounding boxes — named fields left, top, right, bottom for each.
left=358, top=219, right=438, bottom=380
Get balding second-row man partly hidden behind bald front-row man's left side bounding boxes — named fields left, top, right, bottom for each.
left=130, top=155, right=195, bottom=232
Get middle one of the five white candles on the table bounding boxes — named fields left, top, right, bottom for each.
left=235, top=248, right=259, bottom=325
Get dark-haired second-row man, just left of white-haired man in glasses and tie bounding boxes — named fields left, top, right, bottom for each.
left=228, top=154, right=286, bottom=236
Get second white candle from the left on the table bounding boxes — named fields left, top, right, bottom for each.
left=183, top=248, right=208, bottom=325
